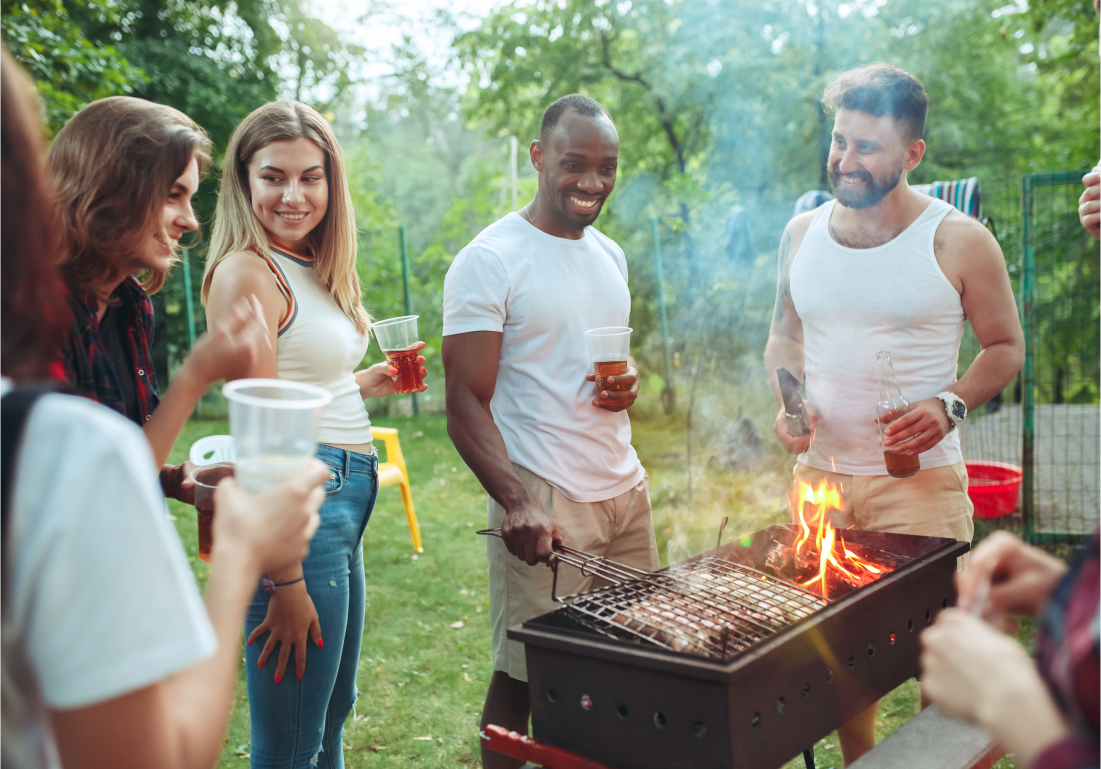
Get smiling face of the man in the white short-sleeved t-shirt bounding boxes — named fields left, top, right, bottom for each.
left=532, top=110, right=619, bottom=232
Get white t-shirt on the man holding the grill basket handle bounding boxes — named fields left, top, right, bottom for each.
left=444, top=213, right=643, bottom=502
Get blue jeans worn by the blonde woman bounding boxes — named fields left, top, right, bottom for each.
left=244, top=445, right=379, bottom=769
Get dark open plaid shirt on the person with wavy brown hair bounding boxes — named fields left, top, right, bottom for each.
left=62, top=275, right=161, bottom=425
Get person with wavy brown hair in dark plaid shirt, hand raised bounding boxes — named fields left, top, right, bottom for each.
left=47, top=96, right=268, bottom=501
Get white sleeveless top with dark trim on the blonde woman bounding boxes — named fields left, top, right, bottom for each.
left=260, top=242, right=371, bottom=444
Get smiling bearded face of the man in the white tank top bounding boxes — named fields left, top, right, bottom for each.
left=829, top=109, right=925, bottom=209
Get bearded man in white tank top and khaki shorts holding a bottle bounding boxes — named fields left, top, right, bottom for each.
left=764, top=64, right=1024, bottom=763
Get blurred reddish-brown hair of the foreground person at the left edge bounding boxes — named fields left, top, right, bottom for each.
left=0, top=47, right=70, bottom=381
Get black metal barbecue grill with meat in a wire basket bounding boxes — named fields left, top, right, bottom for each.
left=509, top=526, right=968, bottom=769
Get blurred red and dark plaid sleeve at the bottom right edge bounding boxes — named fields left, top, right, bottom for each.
left=1034, top=531, right=1101, bottom=769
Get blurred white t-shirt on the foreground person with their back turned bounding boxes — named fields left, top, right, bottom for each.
left=0, top=390, right=217, bottom=769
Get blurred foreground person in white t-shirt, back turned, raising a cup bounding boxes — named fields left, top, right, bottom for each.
left=0, top=51, right=327, bottom=769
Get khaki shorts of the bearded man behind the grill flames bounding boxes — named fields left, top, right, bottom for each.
left=792, top=462, right=974, bottom=557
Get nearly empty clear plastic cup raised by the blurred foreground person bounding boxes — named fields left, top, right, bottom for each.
left=221, top=379, right=333, bottom=494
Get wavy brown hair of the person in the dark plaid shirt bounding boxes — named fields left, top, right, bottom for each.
left=47, top=96, right=210, bottom=294
